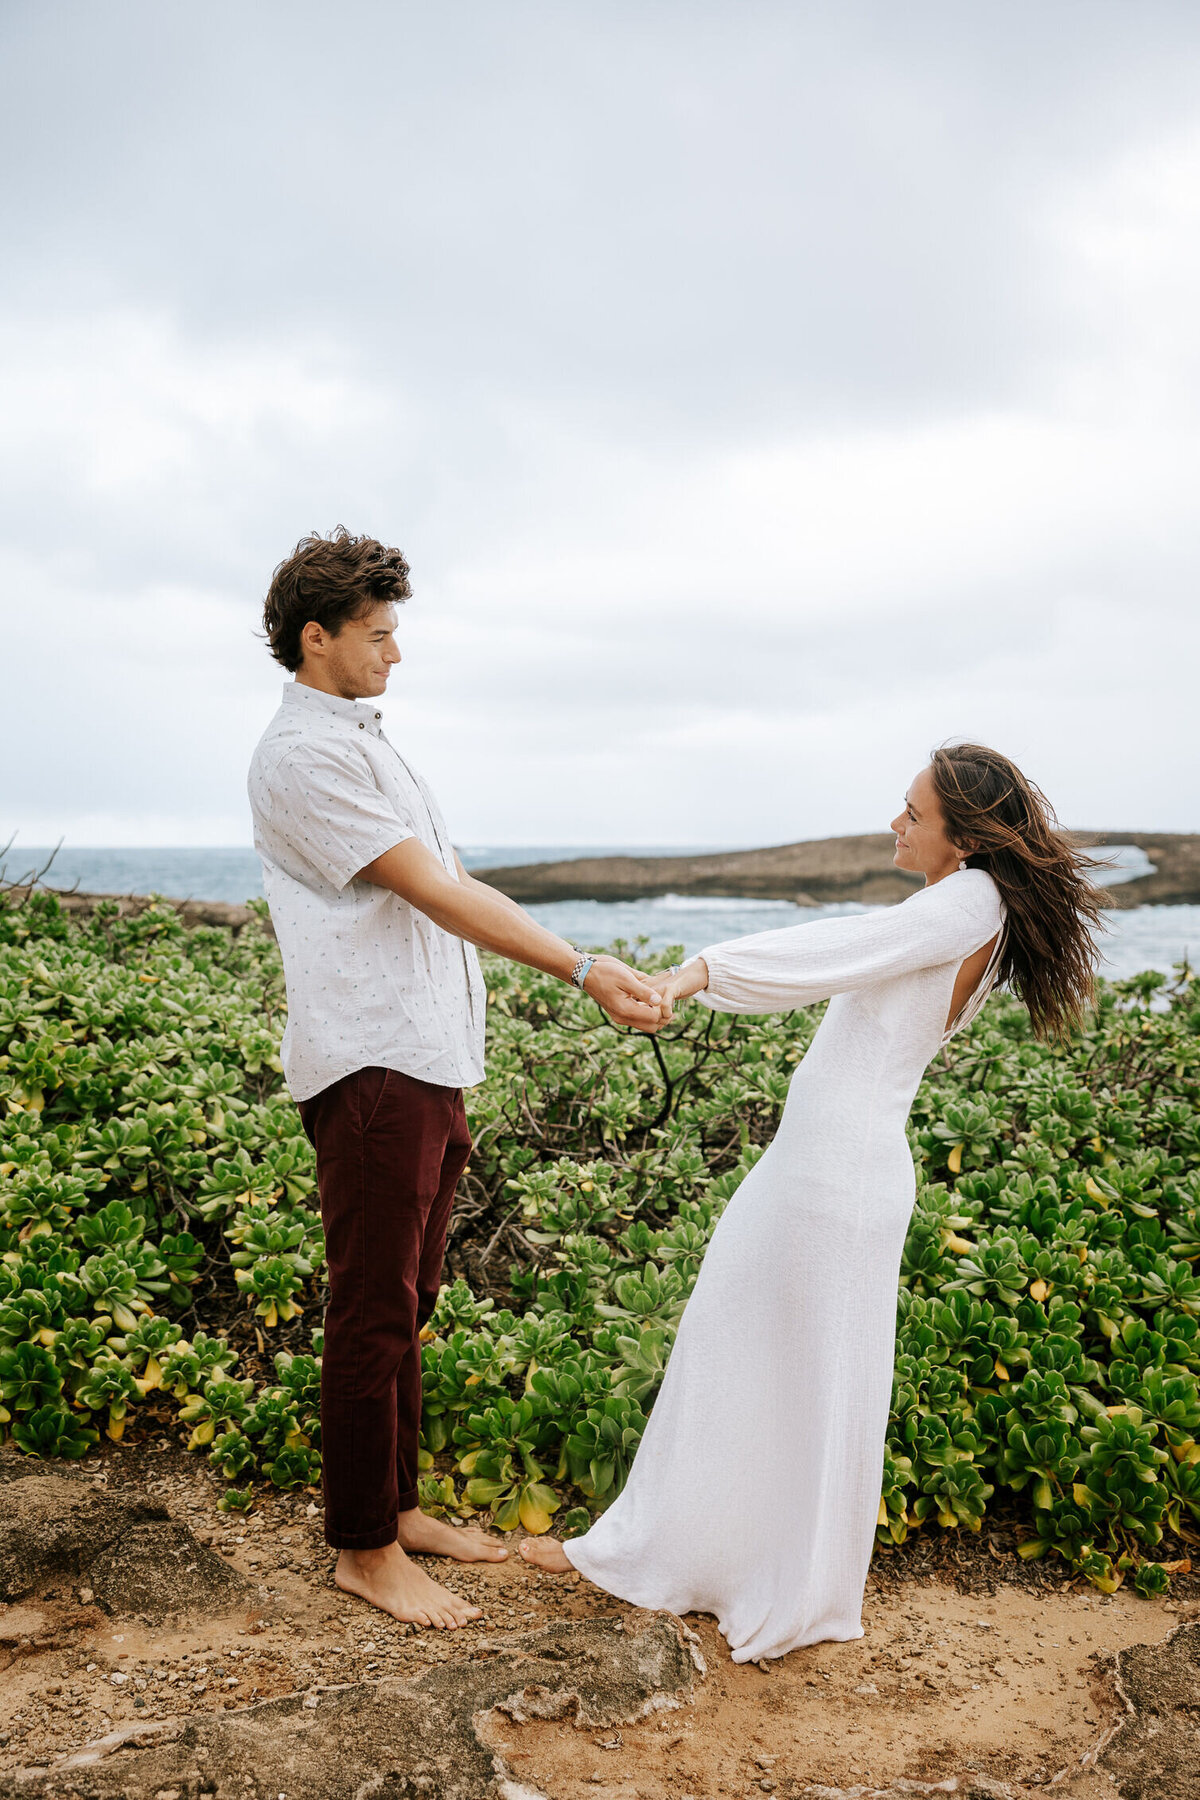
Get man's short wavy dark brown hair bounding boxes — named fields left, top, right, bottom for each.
left=263, top=526, right=412, bottom=671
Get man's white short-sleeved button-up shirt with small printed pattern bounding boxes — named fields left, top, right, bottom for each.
left=248, top=682, right=486, bottom=1100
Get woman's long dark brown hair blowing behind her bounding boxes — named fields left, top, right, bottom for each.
left=930, top=743, right=1101, bottom=1037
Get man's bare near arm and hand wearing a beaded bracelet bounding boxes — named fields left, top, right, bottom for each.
left=358, top=837, right=660, bottom=1031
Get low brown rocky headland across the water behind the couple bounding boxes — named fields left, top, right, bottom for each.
left=471, top=832, right=1200, bottom=907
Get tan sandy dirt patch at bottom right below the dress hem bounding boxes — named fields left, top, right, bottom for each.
left=497, top=1586, right=1200, bottom=1800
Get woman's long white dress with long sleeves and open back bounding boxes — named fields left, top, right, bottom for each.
left=563, top=869, right=1004, bottom=1661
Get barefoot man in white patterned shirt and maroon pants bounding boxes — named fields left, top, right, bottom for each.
left=248, top=527, right=660, bottom=1629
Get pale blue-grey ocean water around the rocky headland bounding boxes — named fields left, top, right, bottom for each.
left=4, top=844, right=1200, bottom=977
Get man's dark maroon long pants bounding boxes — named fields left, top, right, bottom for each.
left=300, top=1069, right=471, bottom=1550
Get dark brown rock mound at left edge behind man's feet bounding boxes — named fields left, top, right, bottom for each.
left=0, top=1465, right=248, bottom=1618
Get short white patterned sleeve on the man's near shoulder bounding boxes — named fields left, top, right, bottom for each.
left=252, top=743, right=416, bottom=893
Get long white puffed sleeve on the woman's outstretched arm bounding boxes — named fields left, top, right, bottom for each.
left=696, top=869, right=1002, bottom=1013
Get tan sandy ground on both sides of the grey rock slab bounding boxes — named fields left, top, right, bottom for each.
left=0, top=1453, right=1200, bottom=1800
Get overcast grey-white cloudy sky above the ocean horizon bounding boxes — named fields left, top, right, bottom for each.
left=0, top=0, right=1200, bottom=844
